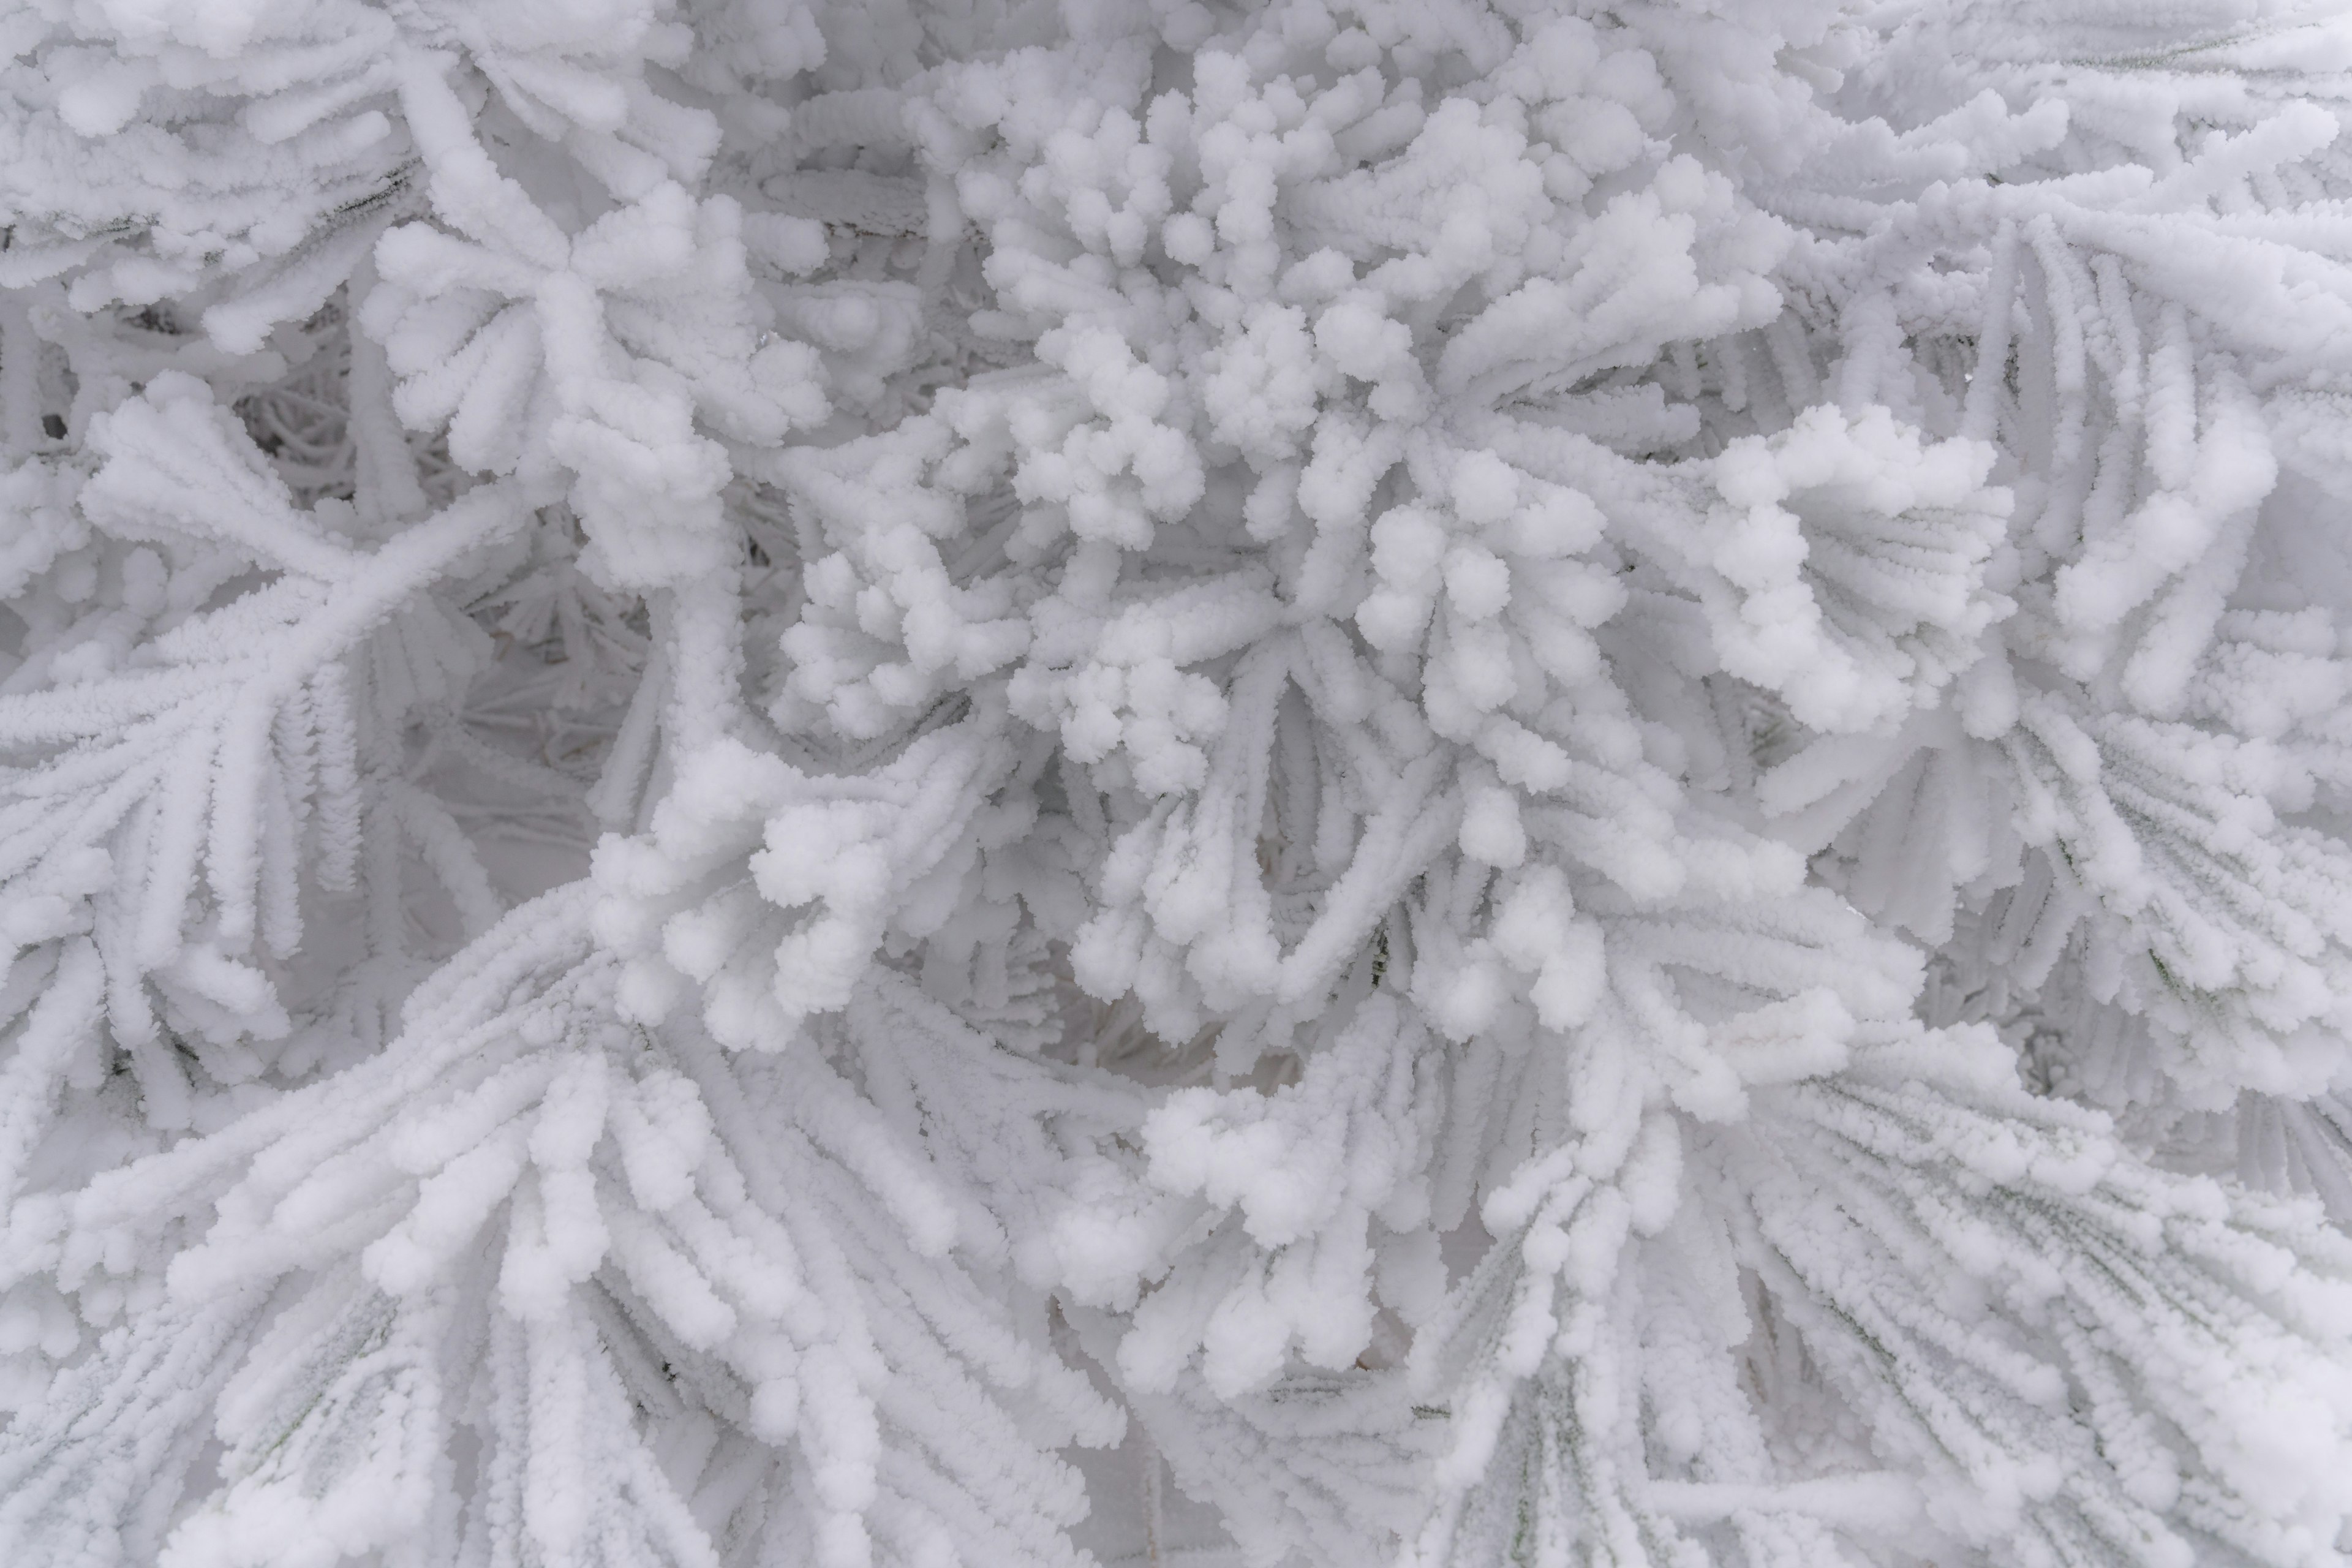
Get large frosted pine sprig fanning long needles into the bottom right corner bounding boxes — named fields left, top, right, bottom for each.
left=1416, top=1032, right=2352, bottom=1563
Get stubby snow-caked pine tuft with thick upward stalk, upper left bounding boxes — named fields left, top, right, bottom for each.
left=364, top=61, right=828, bottom=586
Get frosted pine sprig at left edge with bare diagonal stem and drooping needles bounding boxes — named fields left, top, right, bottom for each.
left=0, top=376, right=527, bottom=1096
